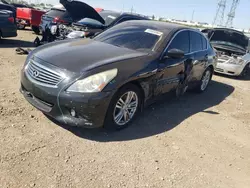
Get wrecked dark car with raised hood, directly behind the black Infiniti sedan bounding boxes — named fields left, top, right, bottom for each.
left=35, top=0, right=149, bottom=46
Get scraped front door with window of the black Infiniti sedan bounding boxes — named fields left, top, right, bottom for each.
left=156, top=30, right=192, bottom=95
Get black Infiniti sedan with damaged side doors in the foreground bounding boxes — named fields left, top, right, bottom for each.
left=20, top=21, right=216, bottom=130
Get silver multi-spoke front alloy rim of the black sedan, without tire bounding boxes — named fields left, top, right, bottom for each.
left=113, top=91, right=139, bottom=126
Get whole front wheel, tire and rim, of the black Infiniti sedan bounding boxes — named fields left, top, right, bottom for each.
left=104, top=84, right=141, bottom=130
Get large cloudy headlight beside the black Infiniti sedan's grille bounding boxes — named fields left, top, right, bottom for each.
left=67, top=69, right=118, bottom=93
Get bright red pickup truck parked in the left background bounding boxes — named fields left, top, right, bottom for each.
left=16, top=8, right=45, bottom=34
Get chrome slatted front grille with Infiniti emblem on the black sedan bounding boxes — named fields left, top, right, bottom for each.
left=26, top=60, right=63, bottom=87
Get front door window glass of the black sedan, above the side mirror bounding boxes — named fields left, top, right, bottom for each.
left=168, top=31, right=190, bottom=54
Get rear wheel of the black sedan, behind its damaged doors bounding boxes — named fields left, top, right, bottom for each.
left=195, top=67, right=213, bottom=93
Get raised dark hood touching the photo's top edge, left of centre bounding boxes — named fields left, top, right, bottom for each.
left=60, top=0, right=105, bottom=24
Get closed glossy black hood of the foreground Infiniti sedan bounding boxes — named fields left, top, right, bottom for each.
left=31, top=39, right=147, bottom=73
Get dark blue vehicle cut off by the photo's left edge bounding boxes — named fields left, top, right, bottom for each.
left=0, top=10, right=17, bottom=39
